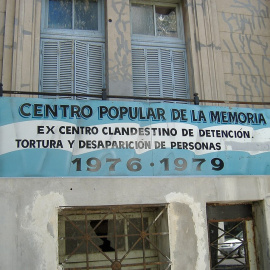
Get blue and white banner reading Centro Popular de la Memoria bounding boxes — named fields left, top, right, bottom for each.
left=0, top=97, right=270, bottom=177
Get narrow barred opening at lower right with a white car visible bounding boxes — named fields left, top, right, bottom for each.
left=207, top=204, right=256, bottom=270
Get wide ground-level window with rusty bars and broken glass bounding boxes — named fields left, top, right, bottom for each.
left=59, top=205, right=171, bottom=270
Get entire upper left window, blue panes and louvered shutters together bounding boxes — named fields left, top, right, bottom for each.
left=40, top=0, right=105, bottom=99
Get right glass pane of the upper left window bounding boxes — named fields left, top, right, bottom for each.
left=74, top=0, right=98, bottom=30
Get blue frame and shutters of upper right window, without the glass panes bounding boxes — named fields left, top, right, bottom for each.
left=130, top=0, right=190, bottom=99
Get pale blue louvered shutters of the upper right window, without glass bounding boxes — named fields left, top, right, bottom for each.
left=132, top=46, right=188, bottom=98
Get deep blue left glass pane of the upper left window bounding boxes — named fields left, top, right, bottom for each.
left=48, top=0, right=72, bottom=29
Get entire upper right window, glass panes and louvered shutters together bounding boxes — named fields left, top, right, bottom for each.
left=131, top=1, right=188, bottom=98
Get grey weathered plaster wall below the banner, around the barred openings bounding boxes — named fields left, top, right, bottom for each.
left=0, top=176, right=270, bottom=270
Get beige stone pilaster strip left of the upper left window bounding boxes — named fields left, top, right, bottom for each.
left=11, top=0, right=41, bottom=91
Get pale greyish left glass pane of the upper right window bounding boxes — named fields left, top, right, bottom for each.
left=131, top=5, right=155, bottom=35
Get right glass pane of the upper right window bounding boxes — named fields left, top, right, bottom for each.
left=156, top=6, right=177, bottom=37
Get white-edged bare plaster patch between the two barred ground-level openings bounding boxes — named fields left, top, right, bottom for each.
left=166, top=193, right=209, bottom=270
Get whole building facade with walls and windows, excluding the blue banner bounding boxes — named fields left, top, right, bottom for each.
left=0, top=0, right=270, bottom=270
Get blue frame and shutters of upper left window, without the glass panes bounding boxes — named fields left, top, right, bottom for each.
left=39, top=0, right=106, bottom=99
